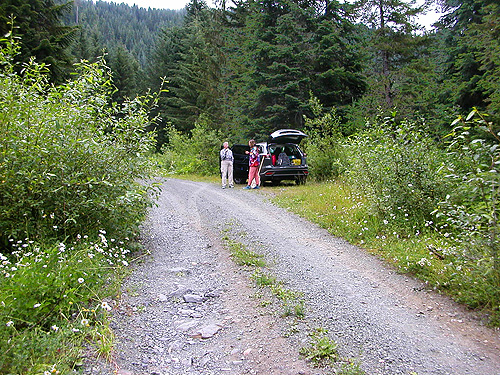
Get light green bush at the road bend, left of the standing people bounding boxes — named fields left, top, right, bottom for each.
left=158, top=118, right=222, bottom=175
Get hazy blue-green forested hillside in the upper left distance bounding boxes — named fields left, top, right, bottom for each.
left=61, top=0, right=186, bottom=67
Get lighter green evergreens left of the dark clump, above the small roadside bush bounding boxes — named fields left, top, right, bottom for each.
left=148, top=0, right=224, bottom=140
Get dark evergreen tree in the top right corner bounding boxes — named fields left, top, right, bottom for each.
left=439, top=0, right=500, bottom=113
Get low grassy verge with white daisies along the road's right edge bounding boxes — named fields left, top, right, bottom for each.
left=274, top=177, right=500, bottom=326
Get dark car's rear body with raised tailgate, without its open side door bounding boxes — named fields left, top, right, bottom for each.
left=257, top=129, right=309, bottom=185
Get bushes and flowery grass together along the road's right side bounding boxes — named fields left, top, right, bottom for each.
left=273, top=103, right=500, bottom=326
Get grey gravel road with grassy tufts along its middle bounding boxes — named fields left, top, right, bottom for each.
left=84, top=179, right=500, bottom=375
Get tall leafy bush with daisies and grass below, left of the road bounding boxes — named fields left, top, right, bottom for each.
left=0, top=33, right=154, bottom=375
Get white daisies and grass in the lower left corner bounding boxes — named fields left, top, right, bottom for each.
left=0, top=235, right=129, bottom=374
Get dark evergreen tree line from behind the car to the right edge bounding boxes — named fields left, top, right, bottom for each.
left=146, top=0, right=499, bottom=145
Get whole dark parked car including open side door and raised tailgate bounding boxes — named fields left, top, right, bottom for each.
left=231, top=129, right=309, bottom=185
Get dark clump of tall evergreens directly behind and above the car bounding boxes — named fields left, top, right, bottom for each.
left=223, top=0, right=364, bottom=137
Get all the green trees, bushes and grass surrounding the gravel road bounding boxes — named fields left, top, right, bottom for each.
left=0, top=0, right=500, bottom=374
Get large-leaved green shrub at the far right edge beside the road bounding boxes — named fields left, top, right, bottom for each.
left=436, top=109, right=500, bottom=319
